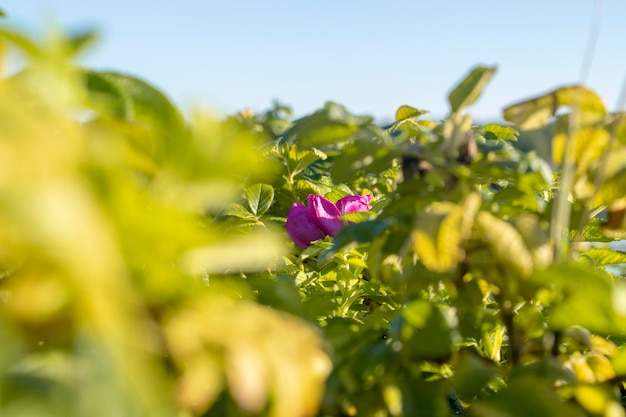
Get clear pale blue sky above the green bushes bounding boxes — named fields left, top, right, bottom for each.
left=1, top=0, right=626, bottom=120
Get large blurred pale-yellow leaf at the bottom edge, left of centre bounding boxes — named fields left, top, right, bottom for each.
left=164, top=293, right=331, bottom=417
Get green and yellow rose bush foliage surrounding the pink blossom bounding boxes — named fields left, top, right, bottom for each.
left=0, top=22, right=626, bottom=417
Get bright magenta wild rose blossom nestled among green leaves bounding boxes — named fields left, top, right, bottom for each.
left=285, top=194, right=372, bottom=248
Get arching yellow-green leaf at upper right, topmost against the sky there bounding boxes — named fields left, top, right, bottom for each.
left=504, top=86, right=606, bottom=130
